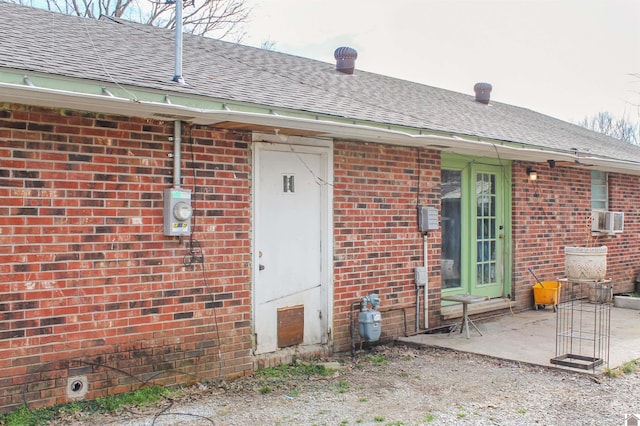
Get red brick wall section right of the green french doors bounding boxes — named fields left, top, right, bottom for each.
left=513, top=162, right=640, bottom=309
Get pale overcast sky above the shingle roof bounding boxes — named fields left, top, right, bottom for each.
left=242, top=0, right=640, bottom=123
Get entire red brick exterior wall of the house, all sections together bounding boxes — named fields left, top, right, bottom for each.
left=0, top=104, right=640, bottom=410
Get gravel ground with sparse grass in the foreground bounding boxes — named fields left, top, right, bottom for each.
left=70, top=346, right=640, bottom=426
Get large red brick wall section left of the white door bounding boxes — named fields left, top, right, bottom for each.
left=0, top=104, right=252, bottom=410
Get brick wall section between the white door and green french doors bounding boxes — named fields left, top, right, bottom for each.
left=333, top=142, right=440, bottom=350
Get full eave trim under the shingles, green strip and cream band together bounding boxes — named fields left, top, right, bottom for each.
left=0, top=68, right=640, bottom=175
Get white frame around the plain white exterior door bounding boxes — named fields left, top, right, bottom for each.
left=251, top=133, right=333, bottom=348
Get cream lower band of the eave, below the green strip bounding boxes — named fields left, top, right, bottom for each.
left=0, top=83, right=640, bottom=175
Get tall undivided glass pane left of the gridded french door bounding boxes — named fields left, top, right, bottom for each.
left=441, top=170, right=462, bottom=289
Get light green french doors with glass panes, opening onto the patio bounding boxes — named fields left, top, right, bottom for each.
left=441, top=157, right=511, bottom=297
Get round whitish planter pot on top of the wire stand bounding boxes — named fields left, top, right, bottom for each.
left=564, top=246, right=607, bottom=281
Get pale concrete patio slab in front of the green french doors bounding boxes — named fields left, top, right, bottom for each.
left=397, top=307, right=640, bottom=373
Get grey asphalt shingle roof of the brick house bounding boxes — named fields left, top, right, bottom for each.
left=0, top=2, right=640, bottom=162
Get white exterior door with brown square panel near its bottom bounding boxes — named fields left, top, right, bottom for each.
left=253, top=144, right=330, bottom=353
